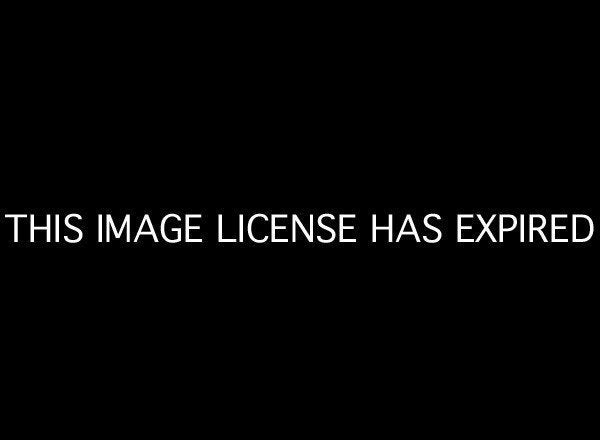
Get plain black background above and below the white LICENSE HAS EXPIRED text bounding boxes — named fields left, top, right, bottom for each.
left=1, top=5, right=598, bottom=433
